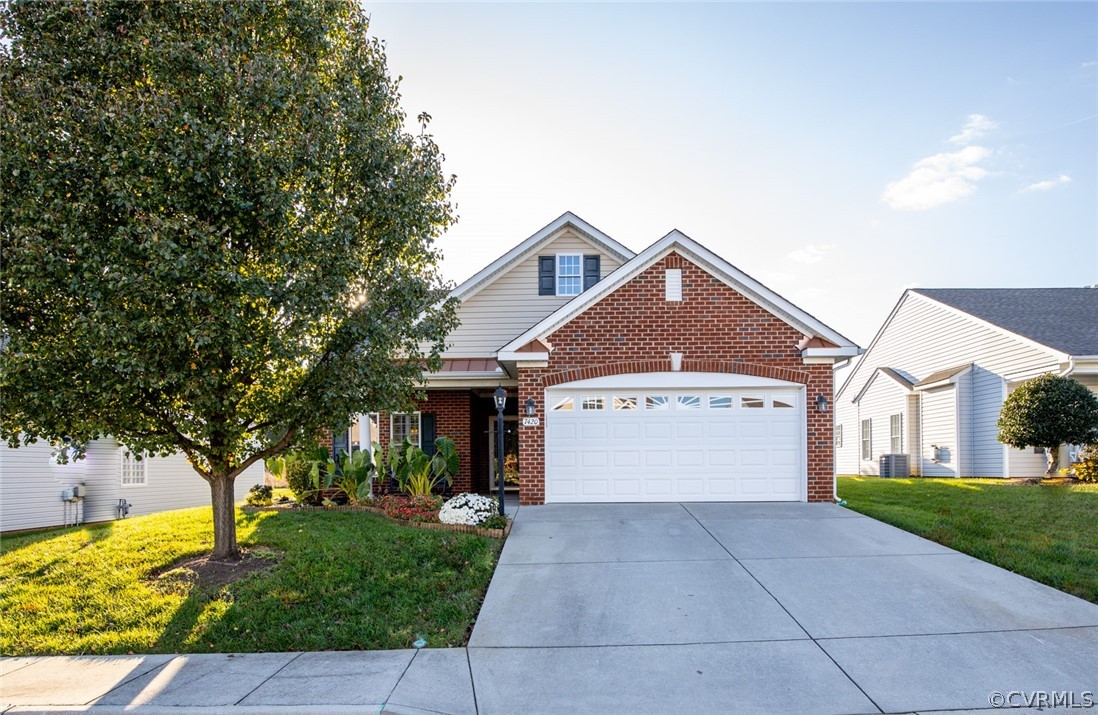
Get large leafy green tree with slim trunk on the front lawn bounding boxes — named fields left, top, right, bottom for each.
left=0, top=0, right=453, bottom=558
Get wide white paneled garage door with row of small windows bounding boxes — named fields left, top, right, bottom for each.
left=546, top=373, right=807, bottom=502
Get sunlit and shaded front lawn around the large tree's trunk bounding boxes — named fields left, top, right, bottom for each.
left=0, top=507, right=501, bottom=656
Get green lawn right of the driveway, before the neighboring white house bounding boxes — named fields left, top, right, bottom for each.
left=839, top=477, right=1098, bottom=607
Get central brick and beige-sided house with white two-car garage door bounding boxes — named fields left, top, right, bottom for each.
left=332, top=213, right=860, bottom=504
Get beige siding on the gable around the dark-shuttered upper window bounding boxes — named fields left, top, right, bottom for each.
left=445, top=227, right=620, bottom=358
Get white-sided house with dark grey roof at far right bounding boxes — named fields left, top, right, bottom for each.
left=836, top=288, right=1098, bottom=477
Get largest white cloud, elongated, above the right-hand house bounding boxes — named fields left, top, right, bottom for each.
left=881, top=145, right=991, bottom=211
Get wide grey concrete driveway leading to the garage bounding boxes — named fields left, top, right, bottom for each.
left=468, top=504, right=1098, bottom=713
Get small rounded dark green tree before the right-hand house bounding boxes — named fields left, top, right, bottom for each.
left=998, top=373, right=1098, bottom=477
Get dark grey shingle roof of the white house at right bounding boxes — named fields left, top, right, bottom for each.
left=912, top=288, right=1098, bottom=355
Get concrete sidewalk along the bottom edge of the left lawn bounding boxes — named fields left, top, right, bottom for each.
left=0, top=648, right=477, bottom=715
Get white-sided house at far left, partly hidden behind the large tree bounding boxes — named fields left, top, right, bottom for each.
left=0, top=438, right=264, bottom=532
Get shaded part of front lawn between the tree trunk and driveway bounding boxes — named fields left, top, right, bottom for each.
left=150, top=512, right=501, bottom=652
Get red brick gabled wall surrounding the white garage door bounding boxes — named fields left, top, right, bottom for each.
left=518, top=253, right=834, bottom=504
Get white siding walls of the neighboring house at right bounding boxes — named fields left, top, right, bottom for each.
left=836, top=293, right=1058, bottom=477
